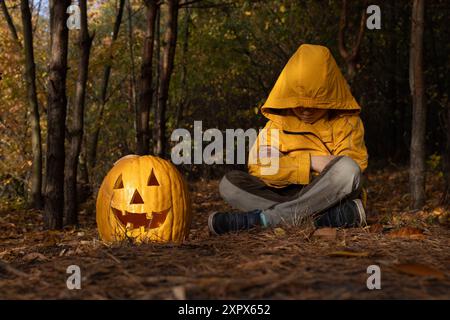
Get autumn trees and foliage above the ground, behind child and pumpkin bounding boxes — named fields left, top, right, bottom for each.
left=0, top=0, right=450, bottom=227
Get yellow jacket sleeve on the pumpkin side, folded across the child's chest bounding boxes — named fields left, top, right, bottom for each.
left=248, top=121, right=311, bottom=187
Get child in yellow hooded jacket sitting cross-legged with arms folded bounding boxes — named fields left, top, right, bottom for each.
left=208, top=44, right=368, bottom=234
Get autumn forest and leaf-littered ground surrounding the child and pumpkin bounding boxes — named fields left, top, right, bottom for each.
left=0, top=0, right=450, bottom=302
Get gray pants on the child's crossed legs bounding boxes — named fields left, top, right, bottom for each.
left=219, top=157, right=361, bottom=227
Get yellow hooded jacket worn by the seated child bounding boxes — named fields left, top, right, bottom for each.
left=249, top=44, right=368, bottom=187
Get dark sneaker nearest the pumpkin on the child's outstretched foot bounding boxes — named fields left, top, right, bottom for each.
left=208, top=210, right=261, bottom=235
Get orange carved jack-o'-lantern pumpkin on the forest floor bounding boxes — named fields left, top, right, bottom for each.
left=96, top=155, right=192, bottom=243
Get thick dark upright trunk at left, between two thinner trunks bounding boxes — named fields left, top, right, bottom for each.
left=44, top=0, right=70, bottom=229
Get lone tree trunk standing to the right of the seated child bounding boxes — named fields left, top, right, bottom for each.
left=409, top=0, right=426, bottom=209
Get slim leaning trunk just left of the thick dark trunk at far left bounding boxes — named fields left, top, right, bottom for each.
left=20, top=0, right=44, bottom=209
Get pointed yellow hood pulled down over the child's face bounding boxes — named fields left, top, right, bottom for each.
left=261, top=44, right=361, bottom=127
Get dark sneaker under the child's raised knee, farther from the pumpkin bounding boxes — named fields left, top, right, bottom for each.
left=314, top=199, right=367, bottom=228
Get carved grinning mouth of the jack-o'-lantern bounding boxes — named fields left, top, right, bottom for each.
left=111, top=207, right=170, bottom=229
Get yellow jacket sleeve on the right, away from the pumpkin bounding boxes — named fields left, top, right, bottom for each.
left=333, top=116, right=368, bottom=171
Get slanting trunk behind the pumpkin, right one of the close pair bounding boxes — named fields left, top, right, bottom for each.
left=153, top=0, right=178, bottom=156
